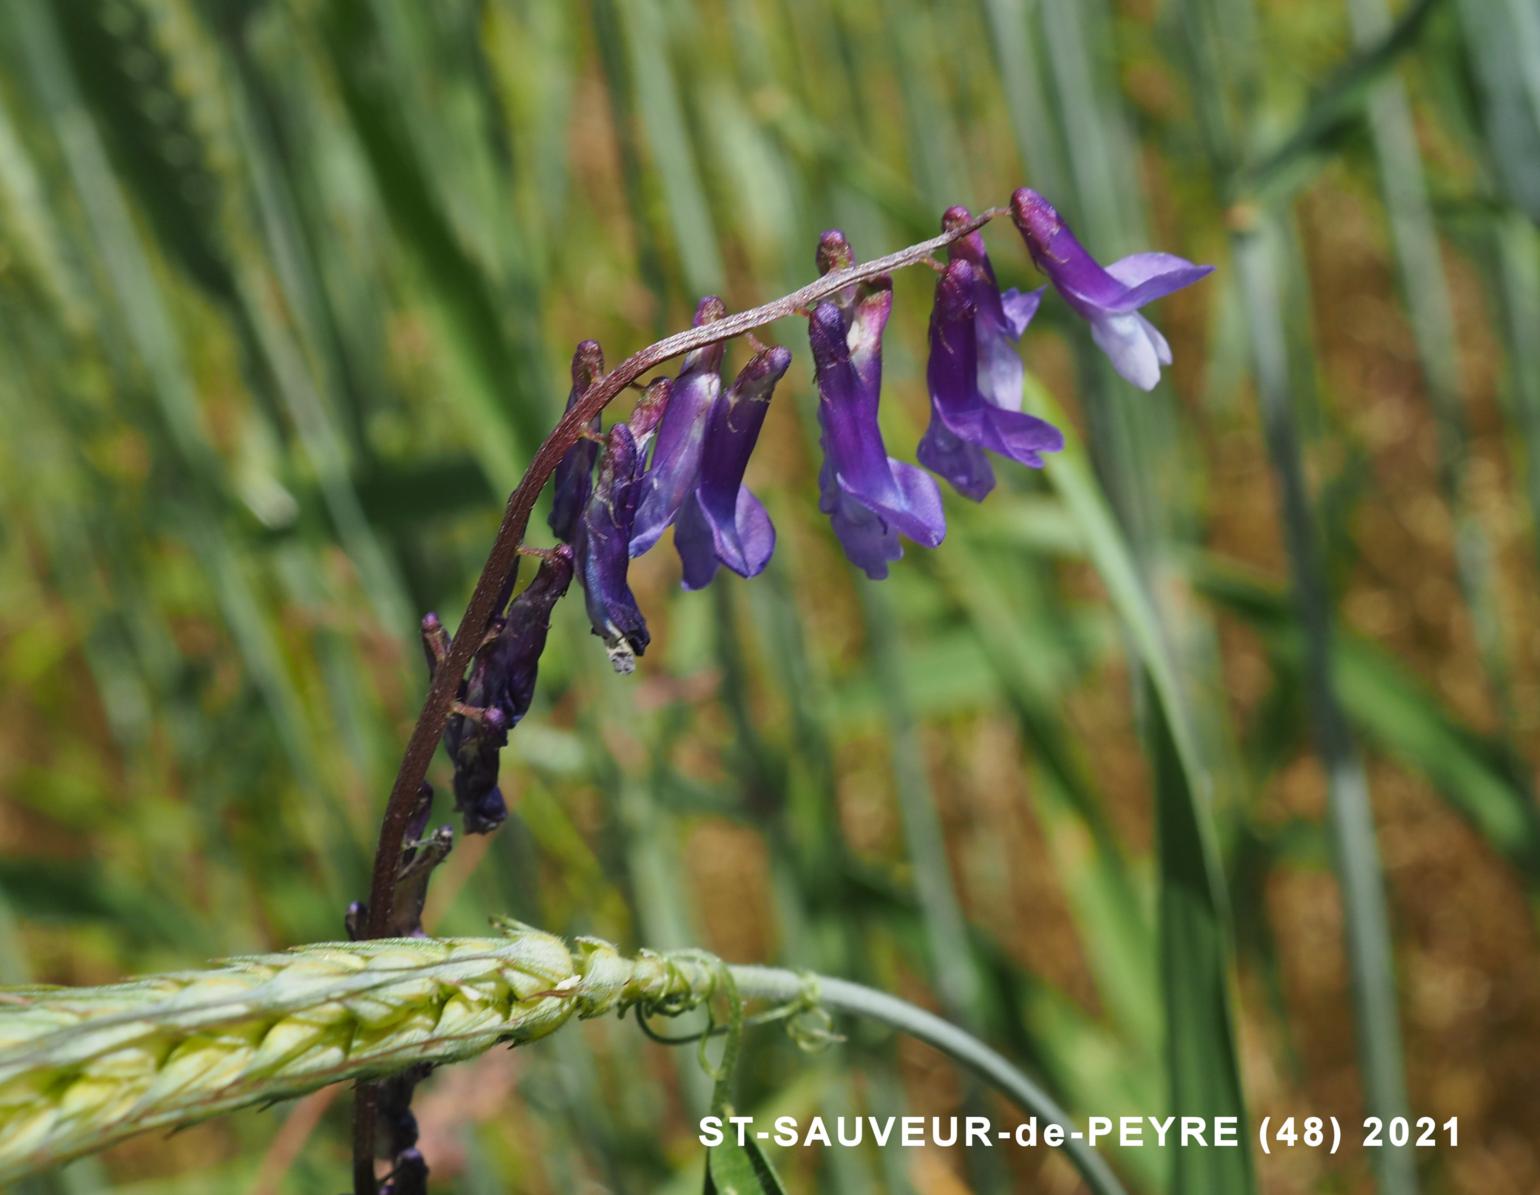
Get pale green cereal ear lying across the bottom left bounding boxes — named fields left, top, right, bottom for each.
left=0, top=922, right=719, bottom=1181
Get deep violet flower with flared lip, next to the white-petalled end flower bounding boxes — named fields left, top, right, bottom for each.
left=919, top=257, right=1064, bottom=502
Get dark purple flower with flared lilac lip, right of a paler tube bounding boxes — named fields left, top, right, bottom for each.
left=677, top=346, right=792, bottom=590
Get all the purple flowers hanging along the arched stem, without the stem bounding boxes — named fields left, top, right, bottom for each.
left=424, top=188, right=1210, bottom=833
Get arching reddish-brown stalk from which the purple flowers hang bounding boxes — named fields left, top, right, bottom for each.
left=353, top=208, right=1007, bottom=1195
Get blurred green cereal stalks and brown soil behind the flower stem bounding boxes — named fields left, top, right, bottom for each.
left=0, top=0, right=1540, bottom=1195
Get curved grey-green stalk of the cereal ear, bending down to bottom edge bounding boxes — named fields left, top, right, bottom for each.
left=728, top=966, right=1124, bottom=1195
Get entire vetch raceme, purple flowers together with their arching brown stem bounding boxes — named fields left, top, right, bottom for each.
left=375, top=188, right=1210, bottom=1195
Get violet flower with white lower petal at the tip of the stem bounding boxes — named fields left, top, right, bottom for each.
left=1010, top=186, right=1214, bottom=390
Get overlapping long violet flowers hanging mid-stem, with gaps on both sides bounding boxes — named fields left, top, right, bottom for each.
left=809, top=233, right=946, bottom=581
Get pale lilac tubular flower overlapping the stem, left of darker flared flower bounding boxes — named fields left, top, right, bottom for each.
left=630, top=296, right=727, bottom=556
